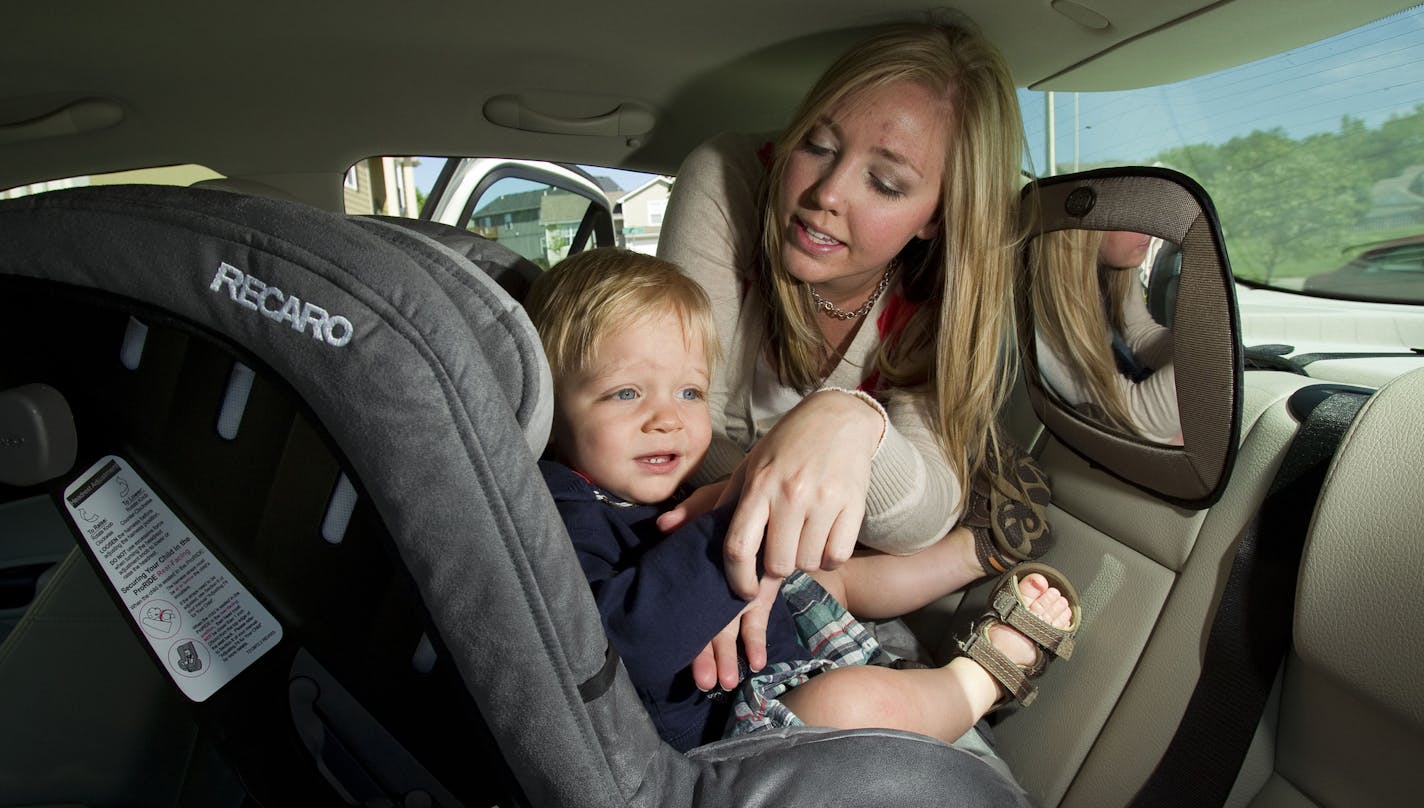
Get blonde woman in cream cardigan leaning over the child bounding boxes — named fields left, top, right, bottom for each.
left=659, top=24, right=1047, bottom=687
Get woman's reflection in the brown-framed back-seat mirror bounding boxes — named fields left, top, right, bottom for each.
left=1032, top=229, right=1182, bottom=445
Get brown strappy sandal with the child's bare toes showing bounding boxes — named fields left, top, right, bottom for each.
left=958, top=563, right=1082, bottom=708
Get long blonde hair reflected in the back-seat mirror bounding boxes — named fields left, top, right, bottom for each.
left=1030, top=229, right=1139, bottom=435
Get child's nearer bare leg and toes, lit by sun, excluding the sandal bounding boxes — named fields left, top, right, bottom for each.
left=782, top=573, right=1071, bottom=742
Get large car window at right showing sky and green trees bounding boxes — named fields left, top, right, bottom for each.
left=1020, top=7, right=1424, bottom=304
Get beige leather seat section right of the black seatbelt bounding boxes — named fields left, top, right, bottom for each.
left=1237, top=371, right=1424, bottom=808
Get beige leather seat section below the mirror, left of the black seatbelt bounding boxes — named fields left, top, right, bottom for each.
left=914, top=372, right=1314, bottom=808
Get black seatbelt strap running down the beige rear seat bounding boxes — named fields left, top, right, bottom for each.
left=1132, top=388, right=1368, bottom=808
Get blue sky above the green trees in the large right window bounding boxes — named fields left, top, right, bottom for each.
left=1020, top=7, right=1424, bottom=172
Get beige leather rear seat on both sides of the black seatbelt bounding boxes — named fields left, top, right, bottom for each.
left=914, top=363, right=1401, bottom=808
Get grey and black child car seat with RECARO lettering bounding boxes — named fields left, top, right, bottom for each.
left=0, top=187, right=1022, bottom=807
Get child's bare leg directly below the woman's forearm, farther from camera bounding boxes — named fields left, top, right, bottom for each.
left=810, top=527, right=984, bottom=620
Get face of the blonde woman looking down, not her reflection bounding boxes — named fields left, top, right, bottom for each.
left=776, top=81, right=953, bottom=296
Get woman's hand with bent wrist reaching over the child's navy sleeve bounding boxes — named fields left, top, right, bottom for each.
left=719, top=390, right=886, bottom=597
